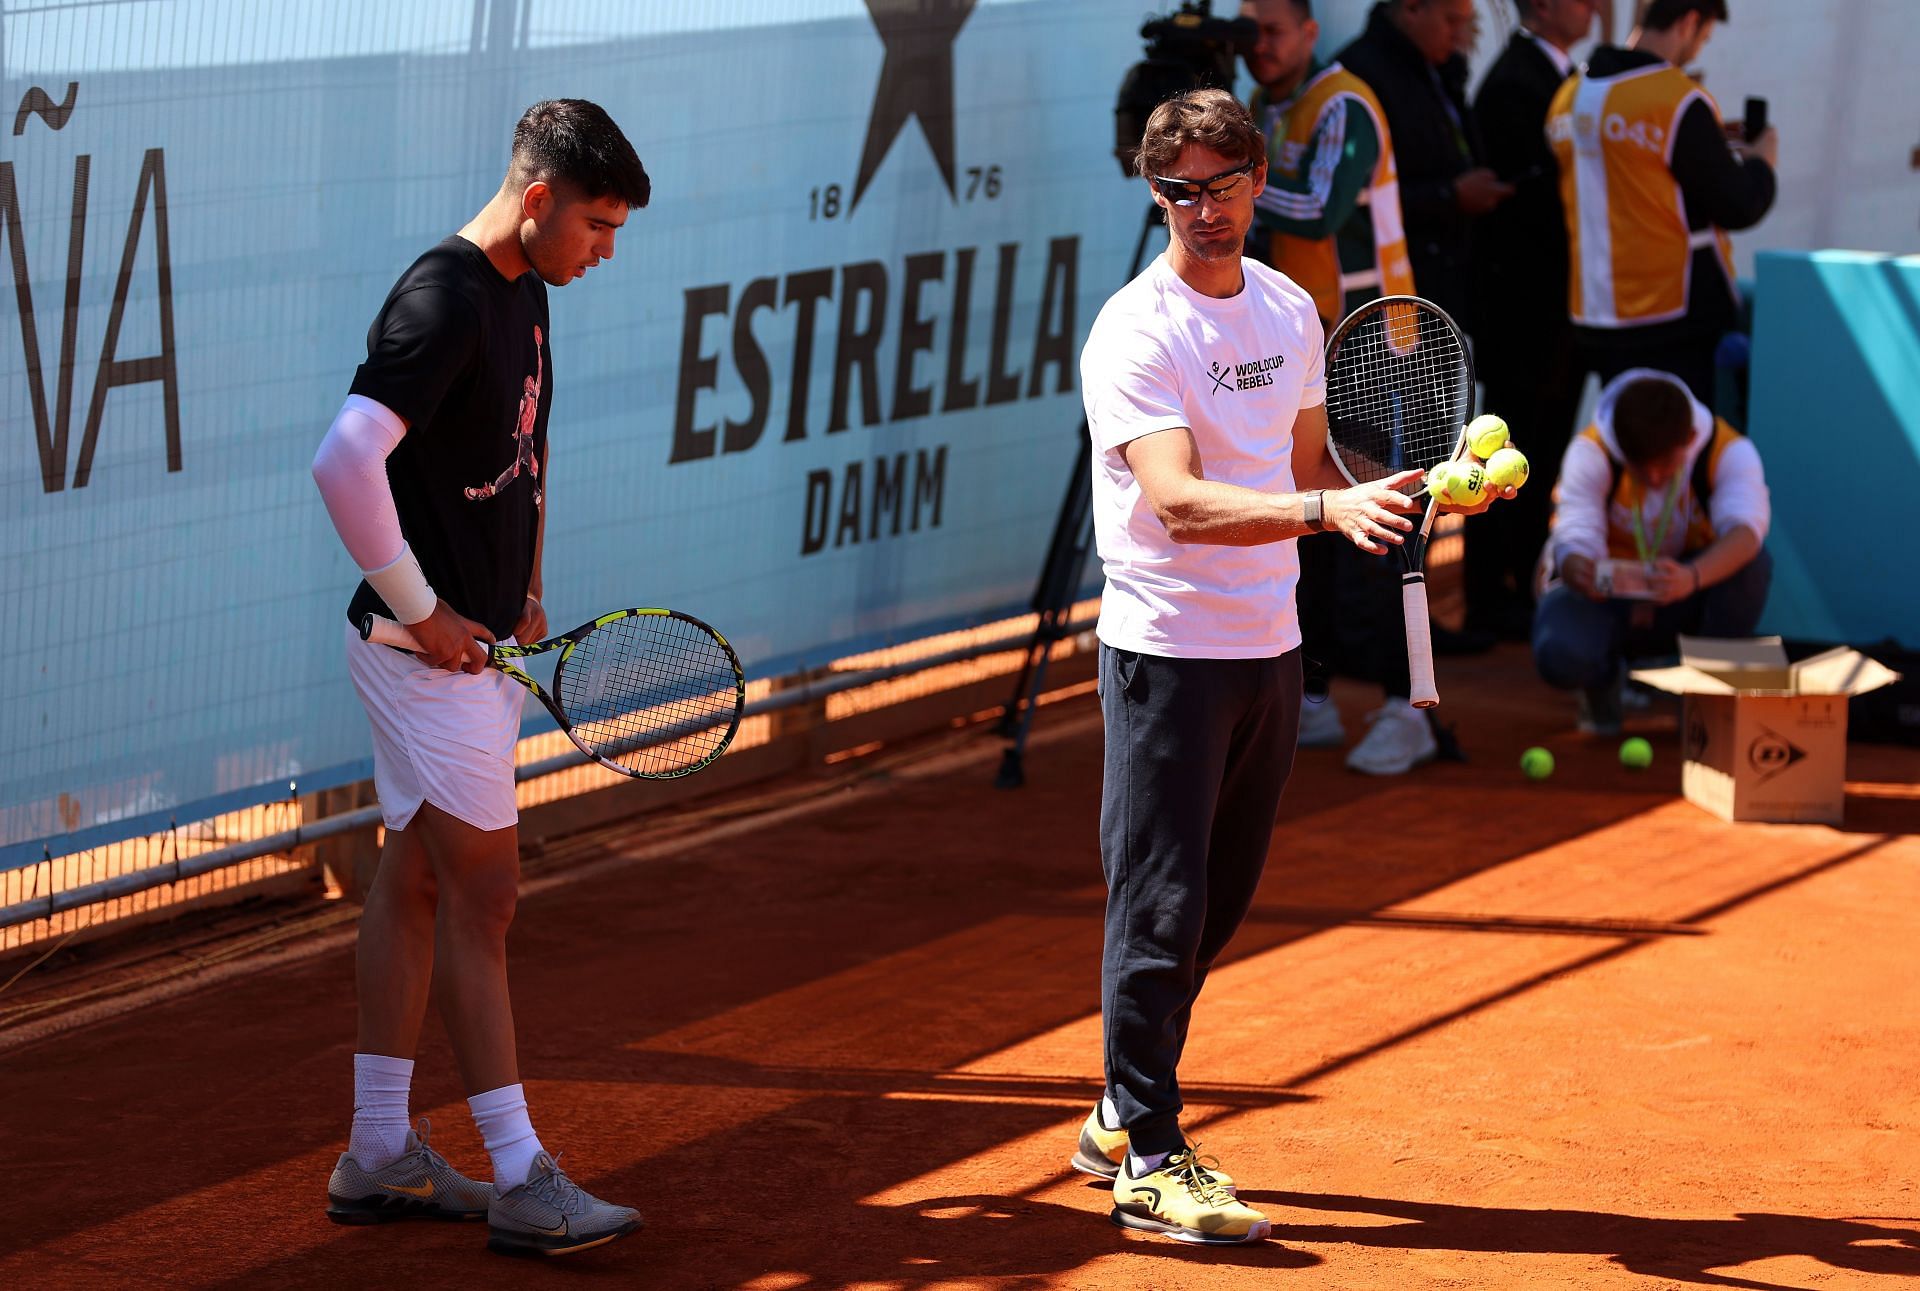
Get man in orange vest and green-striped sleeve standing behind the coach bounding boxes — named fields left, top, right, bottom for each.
left=1240, top=0, right=1438, bottom=774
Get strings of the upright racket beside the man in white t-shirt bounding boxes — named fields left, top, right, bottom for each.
left=1327, top=302, right=1473, bottom=484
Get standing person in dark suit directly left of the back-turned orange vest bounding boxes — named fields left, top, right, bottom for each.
left=1467, top=0, right=1597, bottom=642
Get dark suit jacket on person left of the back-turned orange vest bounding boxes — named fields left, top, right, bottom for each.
left=1473, top=31, right=1571, bottom=378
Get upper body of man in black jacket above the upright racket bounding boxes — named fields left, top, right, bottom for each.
left=1338, top=0, right=1513, bottom=329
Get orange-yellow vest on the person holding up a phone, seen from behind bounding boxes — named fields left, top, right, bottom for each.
left=1548, top=63, right=1738, bottom=329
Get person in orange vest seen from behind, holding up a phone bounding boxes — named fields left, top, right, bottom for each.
left=1536, top=0, right=1778, bottom=400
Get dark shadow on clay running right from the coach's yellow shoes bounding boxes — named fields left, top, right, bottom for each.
left=1244, top=1191, right=1920, bottom=1291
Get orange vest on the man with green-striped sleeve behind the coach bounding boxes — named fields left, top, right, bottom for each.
left=1267, top=63, right=1413, bottom=321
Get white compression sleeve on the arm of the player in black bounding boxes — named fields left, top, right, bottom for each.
left=313, top=394, right=436, bottom=622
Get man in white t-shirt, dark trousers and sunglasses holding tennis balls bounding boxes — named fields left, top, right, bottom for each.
left=1073, top=90, right=1421, bottom=1241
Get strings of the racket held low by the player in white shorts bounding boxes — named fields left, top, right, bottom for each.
left=555, top=615, right=739, bottom=776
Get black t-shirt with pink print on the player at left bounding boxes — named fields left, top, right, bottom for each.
left=348, top=236, right=553, bottom=638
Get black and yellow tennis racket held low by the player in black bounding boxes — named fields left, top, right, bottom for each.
left=361, top=609, right=747, bottom=780
